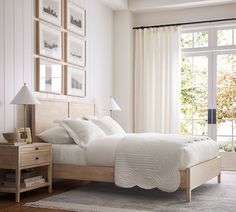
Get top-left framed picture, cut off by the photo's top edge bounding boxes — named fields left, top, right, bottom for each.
left=36, top=0, right=62, bottom=26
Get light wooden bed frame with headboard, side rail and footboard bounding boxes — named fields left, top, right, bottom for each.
left=31, top=99, right=221, bottom=202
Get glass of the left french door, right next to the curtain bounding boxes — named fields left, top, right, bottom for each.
left=181, top=53, right=211, bottom=135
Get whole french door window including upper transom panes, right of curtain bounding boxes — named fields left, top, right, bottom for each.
left=181, top=22, right=236, bottom=151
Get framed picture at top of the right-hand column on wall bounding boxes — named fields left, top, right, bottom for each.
left=65, top=0, right=86, bottom=36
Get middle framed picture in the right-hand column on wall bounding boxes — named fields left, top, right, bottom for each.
left=65, top=33, right=86, bottom=67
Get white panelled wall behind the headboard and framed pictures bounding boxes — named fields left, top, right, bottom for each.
left=0, top=0, right=113, bottom=132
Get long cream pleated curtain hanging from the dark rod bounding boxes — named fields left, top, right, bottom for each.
left=134, top=27, right=181, bottom=133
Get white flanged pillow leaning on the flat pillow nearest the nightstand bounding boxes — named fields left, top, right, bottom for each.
left=55, top=119, right=106, bottom=147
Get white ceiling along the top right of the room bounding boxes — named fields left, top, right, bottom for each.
left=100, top=0, right=236, bottom=13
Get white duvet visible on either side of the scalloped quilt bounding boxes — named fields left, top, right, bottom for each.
left=86, top=136, right=219, bottom=170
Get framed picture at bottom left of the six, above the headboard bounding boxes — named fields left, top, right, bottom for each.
left=36, top=58, right=63, bottom=94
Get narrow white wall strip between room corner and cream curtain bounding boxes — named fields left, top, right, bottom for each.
left=114, top=11, right=133, bottom=132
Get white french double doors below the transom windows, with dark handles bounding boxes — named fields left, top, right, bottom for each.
left=181, top=51, right=236, bottom=151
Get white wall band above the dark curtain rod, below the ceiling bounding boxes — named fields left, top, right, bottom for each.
left=134, top=4, right=236, bottom=26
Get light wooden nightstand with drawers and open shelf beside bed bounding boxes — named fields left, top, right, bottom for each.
left=0, top=143, right=52, bottom=202
